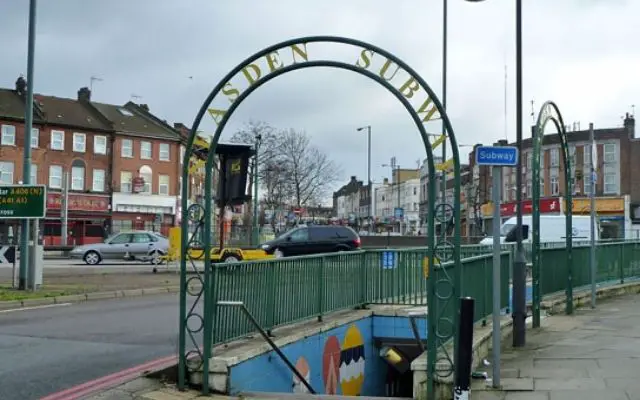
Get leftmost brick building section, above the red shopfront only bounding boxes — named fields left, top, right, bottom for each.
left=0, top=78, right=111, bottom=245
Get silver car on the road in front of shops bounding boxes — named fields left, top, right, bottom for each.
left=70, top=231, right=169, bottom=265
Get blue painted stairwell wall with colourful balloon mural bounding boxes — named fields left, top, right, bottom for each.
left=230, top=317, right=387, bottom=396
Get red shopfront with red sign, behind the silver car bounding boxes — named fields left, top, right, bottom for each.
left=42, top=192, right=111, bottom=246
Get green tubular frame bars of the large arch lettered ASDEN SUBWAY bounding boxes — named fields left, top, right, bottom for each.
left=179, top=36, right=461, bottom=396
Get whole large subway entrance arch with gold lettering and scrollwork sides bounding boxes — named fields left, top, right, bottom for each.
left=178, top=36, right=461, bottom=393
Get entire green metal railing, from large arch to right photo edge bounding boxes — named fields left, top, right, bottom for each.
left=210, top=241, right=640, bottom=343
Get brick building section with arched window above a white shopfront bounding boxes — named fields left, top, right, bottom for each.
left=84, top=95, right=182, bottom=234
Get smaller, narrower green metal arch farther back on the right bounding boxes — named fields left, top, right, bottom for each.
left=532, top=101, right=573, bottom=328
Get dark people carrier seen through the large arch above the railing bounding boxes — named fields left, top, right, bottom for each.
left=260, top=225, right=360, bottom=257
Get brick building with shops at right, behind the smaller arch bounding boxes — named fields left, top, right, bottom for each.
left=469, top=114, right=640, bottom=238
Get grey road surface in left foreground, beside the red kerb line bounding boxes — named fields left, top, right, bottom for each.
left=0, top=295, right=192, bottom=400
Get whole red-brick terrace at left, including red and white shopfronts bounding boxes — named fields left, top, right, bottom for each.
left=0, top=78, right=183, bottom=246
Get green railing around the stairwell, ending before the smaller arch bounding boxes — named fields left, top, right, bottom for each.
left=210, top=249, right=511, bottom=343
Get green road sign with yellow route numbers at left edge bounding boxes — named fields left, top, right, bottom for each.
left=0, top=185, right=47, bottom=219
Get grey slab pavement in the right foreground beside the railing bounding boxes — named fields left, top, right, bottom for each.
left=470, top=295, right=640, bottom=400
